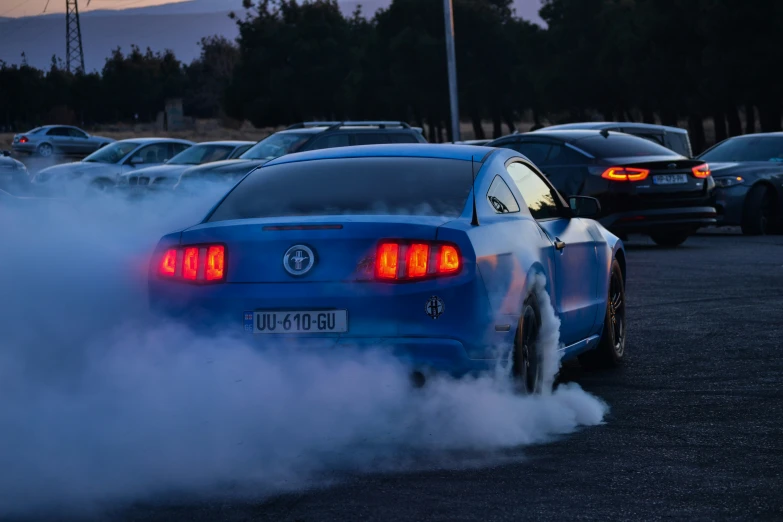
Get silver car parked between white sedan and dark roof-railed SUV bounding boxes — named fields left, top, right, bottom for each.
left=118, top=141, right=255, bottom=190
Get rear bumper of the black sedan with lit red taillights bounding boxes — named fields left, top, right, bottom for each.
left=599, top=206, right=718, bottom=233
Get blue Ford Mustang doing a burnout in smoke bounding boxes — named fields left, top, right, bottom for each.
left=149, top=144, right=625, bottom=392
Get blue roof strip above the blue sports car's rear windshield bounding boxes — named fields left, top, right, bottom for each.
left=264, top=143, right=497, bottom=167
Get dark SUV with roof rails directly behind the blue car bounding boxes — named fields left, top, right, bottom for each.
left=174, top=121, right=427, bottom=190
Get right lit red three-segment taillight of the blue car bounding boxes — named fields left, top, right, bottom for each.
left=375, top=240, right=462, bottom=281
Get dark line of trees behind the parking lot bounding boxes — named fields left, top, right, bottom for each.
left=0, top=0, right=783, bottom=150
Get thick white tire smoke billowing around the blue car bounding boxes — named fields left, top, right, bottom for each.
left=0, top=188, right=608, bottom=518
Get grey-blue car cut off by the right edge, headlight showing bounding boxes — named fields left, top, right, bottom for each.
left=698, top=132, right=783, bottom=235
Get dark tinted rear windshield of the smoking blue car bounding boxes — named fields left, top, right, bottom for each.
left=207, top=154, right=473, bottom=221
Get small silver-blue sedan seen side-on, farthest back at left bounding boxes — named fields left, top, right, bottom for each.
left=11, top=125, right=116, bottom=158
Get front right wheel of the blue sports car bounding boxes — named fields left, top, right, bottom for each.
left=579, top=259, right=626, bottom=369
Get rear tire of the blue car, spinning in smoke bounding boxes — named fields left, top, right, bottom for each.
left=511, top=295, right=543, bottom=394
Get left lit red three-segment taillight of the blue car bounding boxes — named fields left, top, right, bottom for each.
left=158, top=245, right=226, bottom=283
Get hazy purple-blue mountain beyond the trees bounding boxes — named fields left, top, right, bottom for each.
left=0, top=0, right=543, bottom=71
